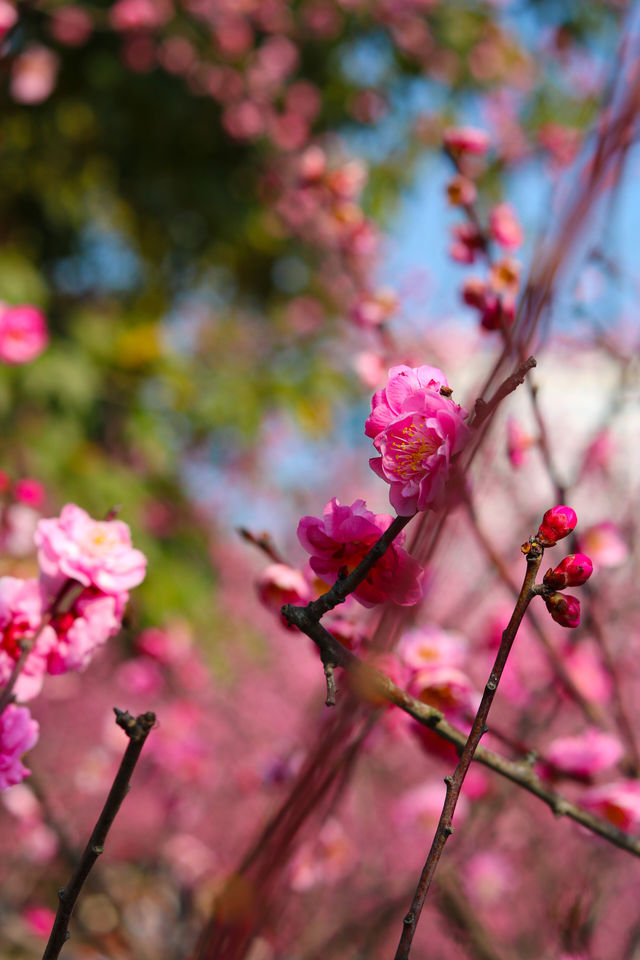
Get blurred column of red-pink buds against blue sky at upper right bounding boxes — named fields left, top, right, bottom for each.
left=443, top=127, right=524, bottom=330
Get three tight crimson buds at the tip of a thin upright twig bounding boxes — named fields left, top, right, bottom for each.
left=535, top=505, right=593, bottom=627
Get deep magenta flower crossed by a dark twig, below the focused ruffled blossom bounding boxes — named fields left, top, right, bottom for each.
left=298, top=497, right=423, bottom=607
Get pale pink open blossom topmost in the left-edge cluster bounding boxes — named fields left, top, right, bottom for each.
left=35, top=503, right=147, bottom=594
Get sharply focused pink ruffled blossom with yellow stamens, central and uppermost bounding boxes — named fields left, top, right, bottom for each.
left=365, top=365, right=469, bottom=516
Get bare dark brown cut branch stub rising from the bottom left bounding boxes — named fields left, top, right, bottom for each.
left=42, top=707, right=156, bottom=960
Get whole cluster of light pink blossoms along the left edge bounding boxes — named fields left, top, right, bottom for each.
left=0, top=504, right=146, bottom=787
